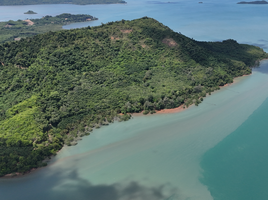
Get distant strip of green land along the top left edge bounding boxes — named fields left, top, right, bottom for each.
left=0, top=0, right=126, bottom=6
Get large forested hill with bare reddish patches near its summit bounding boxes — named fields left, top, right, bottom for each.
left=0, top=17, right=268, bottom=176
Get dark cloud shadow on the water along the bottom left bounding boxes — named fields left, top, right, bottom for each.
left=0, top=170, right=179, bottom=200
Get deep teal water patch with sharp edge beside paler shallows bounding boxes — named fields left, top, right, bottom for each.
left=201, top=65, right=268, bottom=200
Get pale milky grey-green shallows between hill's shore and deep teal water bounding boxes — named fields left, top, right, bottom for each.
left=0, top=61, right=268, bottom=200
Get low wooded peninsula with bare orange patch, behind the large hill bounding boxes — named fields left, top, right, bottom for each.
left=0, top=11, right=98, bottom=43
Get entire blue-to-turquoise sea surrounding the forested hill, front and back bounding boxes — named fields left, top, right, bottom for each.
left=0, top=0, right=268, bottom=200
